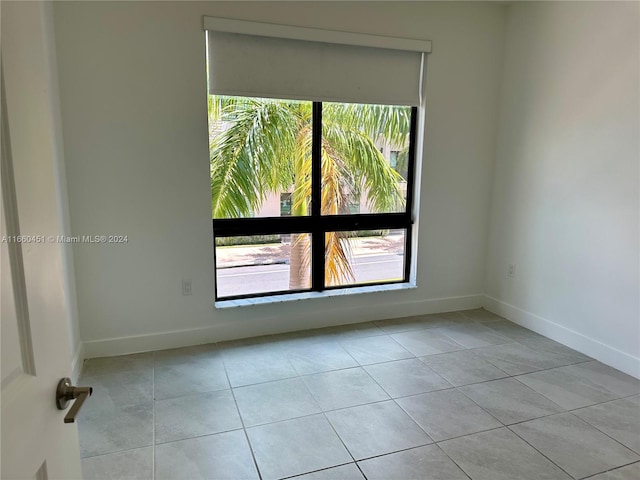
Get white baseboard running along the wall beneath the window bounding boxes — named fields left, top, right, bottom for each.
left=83, top=294, right=484, bottom=358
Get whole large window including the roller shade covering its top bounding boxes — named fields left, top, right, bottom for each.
left=205, top=18, right=430, bottom=300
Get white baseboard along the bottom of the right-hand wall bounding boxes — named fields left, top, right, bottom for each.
left=484, top=295, right=640, bottom=378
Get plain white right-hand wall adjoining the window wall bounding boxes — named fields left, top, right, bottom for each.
left=486, top=2, right=640, bottom=376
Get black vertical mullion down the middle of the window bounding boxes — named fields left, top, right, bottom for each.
left=311, top=102, right=325, bottom=291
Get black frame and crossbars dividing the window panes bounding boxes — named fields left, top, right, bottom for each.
left=212, top=102, right=418, bottom=301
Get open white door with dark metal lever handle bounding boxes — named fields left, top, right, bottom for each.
left=0, top=1, right=84, bottom=480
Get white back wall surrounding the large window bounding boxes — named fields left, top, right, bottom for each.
left=54, top=2, right=505, bottom=356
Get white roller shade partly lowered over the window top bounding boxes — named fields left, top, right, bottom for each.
left=205, top=17, right=431, bottom=106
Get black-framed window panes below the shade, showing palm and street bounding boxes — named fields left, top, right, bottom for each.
left=209, top=95, right=415, bottom=299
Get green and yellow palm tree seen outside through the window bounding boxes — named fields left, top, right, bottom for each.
left=209, top=95, right=410, bottom=289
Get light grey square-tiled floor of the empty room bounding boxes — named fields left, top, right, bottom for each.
left=78, top=310, right=640, bottom=480
